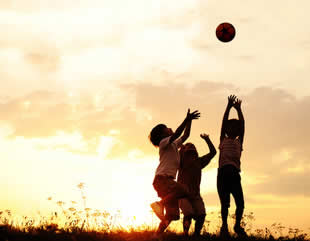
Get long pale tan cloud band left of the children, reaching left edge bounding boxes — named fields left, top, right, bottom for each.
left=0, top=89, right=153, bottom=158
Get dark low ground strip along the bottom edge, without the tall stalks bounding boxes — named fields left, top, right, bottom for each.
left=0, top=226, right=307, bottom=241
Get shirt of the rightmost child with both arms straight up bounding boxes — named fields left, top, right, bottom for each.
left=219, top=137, right=242, bottom=171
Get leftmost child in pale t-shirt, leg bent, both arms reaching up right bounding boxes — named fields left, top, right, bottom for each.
left=149, top=109, right=200, bottom=233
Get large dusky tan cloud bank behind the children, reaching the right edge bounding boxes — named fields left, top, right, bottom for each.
left=124, top=81, right=310, bottom=195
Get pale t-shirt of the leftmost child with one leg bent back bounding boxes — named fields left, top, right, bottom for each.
left=155, top=136, right=182, bottom=178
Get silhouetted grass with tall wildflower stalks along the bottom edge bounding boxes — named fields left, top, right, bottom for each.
left=0, top=183, right=309, bottom=241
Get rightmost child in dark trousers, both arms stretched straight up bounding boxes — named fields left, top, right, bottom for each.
left=217, top=95, right=246, bottom=236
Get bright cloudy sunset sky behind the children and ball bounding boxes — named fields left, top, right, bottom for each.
left=0, top=0, right=310, bottom=231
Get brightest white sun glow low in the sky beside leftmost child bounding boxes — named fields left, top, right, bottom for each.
left=89, top=160, right=158, bottom=227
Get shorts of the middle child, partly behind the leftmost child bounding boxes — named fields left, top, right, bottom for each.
left=179, top=194, right=206, bottom=217
